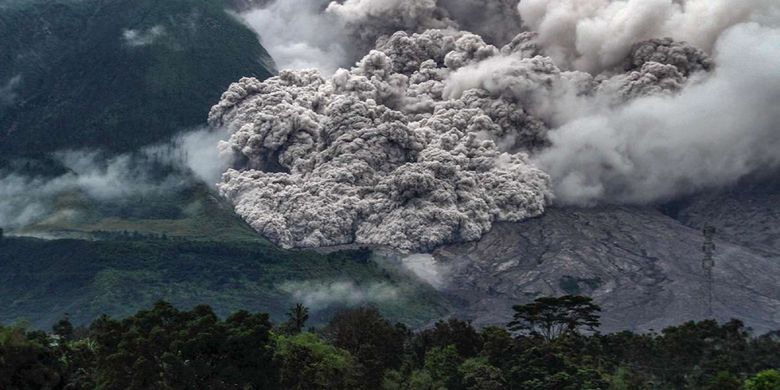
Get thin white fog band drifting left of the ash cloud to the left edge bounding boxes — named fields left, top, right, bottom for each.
left=0, top=129, right=229, bottom=228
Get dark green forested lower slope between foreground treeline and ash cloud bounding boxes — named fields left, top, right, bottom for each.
left=0, top=238, right=449, bottom=329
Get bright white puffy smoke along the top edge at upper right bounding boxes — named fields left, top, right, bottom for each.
left=518, top=0, right=777, bottom=73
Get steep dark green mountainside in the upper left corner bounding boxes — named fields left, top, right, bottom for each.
left=0, top=0, right=273, bottom=157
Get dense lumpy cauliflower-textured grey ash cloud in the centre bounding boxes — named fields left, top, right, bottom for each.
left=210, top=30, right=550, bottom=250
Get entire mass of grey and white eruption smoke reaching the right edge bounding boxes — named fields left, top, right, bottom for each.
left=218, top=0, right=780, bottom=251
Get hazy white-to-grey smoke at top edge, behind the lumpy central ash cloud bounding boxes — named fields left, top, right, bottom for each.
left=241, top=0, right=520, bottom=75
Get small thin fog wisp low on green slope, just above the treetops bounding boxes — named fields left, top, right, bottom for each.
left=279, top=281, right=400, bottom=309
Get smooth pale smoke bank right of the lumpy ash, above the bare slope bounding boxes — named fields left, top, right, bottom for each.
left=536, top=24, right=780, bottom=204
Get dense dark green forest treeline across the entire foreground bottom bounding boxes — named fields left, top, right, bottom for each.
left=0, top=296, right=780, bottom=390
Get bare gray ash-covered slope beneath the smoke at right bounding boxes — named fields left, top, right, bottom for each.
left=435, top=198, right=780, bottom=331
